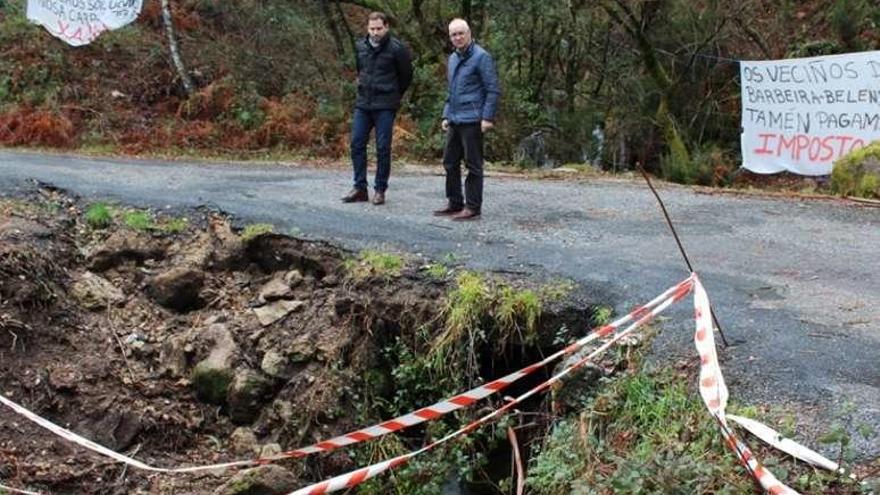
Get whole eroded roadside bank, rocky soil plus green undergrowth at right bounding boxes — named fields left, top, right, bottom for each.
left=0, top=190, right=876, bottom=495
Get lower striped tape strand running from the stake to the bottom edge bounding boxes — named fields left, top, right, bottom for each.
left=288, top=276, right=695, bottom=495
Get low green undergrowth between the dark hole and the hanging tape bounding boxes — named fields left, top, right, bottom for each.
left=527, top=371, right=751, bottom=495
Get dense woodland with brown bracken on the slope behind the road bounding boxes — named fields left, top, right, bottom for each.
left=0, top=0, right=880, bottom=184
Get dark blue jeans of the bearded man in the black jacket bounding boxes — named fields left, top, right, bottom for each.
left=351, top=108, right=395, bottom=192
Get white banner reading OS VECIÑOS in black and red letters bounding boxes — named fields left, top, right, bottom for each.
left=740, top=51, right=880, bottom=175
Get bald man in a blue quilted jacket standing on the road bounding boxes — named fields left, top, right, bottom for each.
left=434, top=19, right=501, bottom=220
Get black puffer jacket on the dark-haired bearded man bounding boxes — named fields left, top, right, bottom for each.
left=355, top=36, right=412, bottom=110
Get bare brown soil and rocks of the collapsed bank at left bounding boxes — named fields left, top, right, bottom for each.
left=0, top=190, right=600, bottom=494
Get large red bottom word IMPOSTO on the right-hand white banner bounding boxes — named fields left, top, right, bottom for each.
left=752, top=133, right=866, bottom=163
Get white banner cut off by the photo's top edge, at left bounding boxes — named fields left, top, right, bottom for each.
left=27, top=0, right=143, bottom=46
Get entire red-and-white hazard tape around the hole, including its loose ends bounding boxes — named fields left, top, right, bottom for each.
left=0, top=274, right=837, bottom=495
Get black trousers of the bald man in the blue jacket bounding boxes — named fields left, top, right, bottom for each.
left=443, top=122, right=483, bottom=212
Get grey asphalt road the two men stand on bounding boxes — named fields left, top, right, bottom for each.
left=0, top=150, right=880, bottom=460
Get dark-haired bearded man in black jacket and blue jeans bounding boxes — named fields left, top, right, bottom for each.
left=342, top=12, right=413, bottom=205
